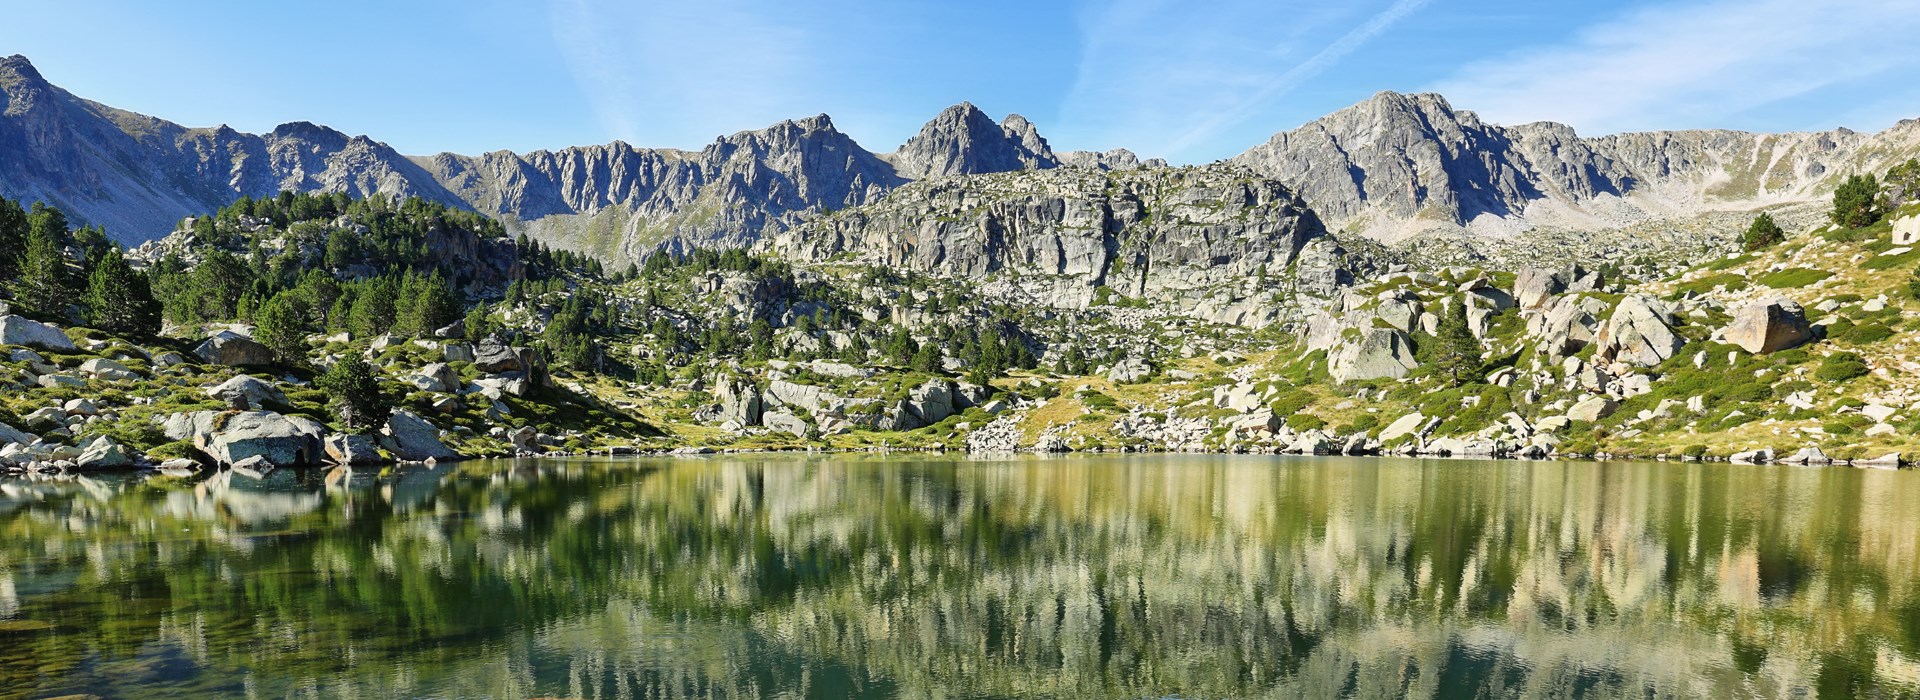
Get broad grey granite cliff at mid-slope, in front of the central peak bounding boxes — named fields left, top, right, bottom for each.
left=762, top=165, right=1344, bottom=326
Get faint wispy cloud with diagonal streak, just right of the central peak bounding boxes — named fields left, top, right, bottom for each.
left=1062, top=0, right=1430, bottom=159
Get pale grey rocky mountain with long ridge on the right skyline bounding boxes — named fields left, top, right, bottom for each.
left=1233, top=92, right=1920, bottom=240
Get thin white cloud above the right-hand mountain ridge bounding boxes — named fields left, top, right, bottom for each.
left=1434, top=0, right=1920, bottom=132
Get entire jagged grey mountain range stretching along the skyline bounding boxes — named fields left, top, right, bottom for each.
left=0, top=56, right=1920, bottom=263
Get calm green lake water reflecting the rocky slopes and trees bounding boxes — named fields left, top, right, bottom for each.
left=0, top=456, right=1920, bottom=698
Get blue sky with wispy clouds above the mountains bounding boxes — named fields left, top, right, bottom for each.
left=0, top=0, right=1920, bottom=163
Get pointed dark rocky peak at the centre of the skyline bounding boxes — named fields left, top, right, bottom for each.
left=893, top=102, right=1060, bottom=180
